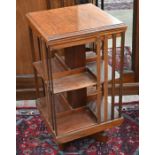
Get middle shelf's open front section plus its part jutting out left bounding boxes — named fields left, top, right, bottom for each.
left=33, top=61, right=96, bottom=94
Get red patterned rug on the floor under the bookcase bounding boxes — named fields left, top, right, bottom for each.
left=16, top=103, right=139, bottom=155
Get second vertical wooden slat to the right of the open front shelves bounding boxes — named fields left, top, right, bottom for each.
left=103, top=36, right=108, bottom=122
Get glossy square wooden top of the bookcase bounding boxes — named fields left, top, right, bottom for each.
left=26, top=4, right=126, bottom=42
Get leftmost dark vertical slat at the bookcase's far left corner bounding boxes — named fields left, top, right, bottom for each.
left=29, top=28, right=39, bottom=98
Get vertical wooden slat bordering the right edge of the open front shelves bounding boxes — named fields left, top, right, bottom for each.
left=96, top=38, right=101, bottom=123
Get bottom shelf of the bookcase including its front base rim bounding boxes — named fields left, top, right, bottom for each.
left=37, top=97, right=123, bottom=144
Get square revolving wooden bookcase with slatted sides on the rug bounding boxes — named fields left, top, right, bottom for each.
left=26, top=4, right=126, bottom=144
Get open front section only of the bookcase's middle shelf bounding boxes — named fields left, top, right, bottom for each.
left=53, top=69, right=96, bottom=94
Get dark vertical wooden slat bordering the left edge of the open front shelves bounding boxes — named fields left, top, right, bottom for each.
left=46, top=48, right=57, bottom=135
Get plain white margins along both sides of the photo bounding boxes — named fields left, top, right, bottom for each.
left=0, top=0, right=155, bottom=155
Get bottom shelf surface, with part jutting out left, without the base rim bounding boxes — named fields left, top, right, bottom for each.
left=37, top=98, right=97, bottom=136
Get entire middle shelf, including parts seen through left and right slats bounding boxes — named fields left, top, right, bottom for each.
left=33, top=57, right=120, bottom=94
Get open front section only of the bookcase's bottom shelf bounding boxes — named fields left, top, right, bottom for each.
left=57, top=107, right=97, bottom=136
